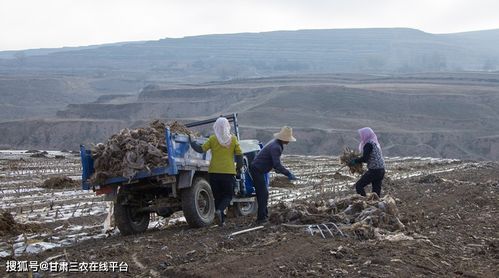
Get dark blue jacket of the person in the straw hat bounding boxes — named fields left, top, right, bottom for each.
left=251, top=139, right=289, bottom=176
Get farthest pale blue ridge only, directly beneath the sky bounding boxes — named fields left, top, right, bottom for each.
left=0, top=28, right=499, bottom=82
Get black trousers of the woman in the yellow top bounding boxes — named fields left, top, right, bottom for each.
left=210, top=173, right=236, bottom=221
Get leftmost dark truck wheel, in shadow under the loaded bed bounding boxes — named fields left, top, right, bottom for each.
left=114, top=202, right=150, bottom=236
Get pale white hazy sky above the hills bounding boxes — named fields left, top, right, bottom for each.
left=0, top=0, right=499, bottom=50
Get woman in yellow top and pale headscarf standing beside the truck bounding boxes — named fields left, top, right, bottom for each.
left=189, top=117, right=243, bottom=226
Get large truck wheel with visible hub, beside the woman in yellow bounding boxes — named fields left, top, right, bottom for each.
left=182, top=178, right=215, bottom=228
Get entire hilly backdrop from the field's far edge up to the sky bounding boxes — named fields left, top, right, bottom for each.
left=0, top=28, right=499, bottom=160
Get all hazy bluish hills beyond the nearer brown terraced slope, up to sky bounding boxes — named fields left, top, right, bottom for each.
left=0, top=28, right=499, bottom=120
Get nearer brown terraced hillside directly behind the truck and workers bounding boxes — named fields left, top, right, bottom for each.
left=0, top=73, right=499, bottom=160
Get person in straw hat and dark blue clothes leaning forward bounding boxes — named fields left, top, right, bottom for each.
left=250, top=126, right=296, bottom=224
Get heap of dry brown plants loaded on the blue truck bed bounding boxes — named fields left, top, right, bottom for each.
left=90, top=120, right=191, bottom=183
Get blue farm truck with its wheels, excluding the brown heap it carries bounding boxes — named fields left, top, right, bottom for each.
left=80, top=113, right=268, bottom=235
